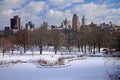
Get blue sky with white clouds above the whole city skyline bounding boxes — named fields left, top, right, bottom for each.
left=0, top=0, right=120, bottom=29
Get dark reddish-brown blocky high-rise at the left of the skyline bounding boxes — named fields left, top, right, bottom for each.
left=10, top=16, right=20, bottom=29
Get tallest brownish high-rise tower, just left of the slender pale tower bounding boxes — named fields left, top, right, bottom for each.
left=72, top=14, right=81, bottom=31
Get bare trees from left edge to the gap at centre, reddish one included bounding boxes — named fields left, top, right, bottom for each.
left=0, top=28, right=65, bottom=56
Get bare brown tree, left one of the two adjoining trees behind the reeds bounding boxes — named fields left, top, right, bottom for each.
left=29, top=28, right=48, bottom=54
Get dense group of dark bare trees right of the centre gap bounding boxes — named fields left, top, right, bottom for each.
left=75, top=28, right=120, bottom=54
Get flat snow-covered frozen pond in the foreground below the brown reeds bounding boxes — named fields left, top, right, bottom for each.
left=0, top=57, right=120, bottom=80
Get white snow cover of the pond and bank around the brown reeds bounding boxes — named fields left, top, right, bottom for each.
left=0, top=53, right=120, bottom=80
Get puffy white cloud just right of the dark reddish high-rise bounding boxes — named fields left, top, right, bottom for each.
left=14, top=1, right=48, bottom=27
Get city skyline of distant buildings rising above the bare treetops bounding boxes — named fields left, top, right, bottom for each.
left=1, top=14, right=120, bottom=32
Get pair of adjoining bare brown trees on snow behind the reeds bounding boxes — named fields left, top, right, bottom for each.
left=28, top=28, right=65, bottom=54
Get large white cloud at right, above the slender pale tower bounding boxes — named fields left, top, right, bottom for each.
left=72, top=3, right=120, bottom=25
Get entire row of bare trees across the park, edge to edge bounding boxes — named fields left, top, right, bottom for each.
left=0, top=28, right=120, bottom=56
